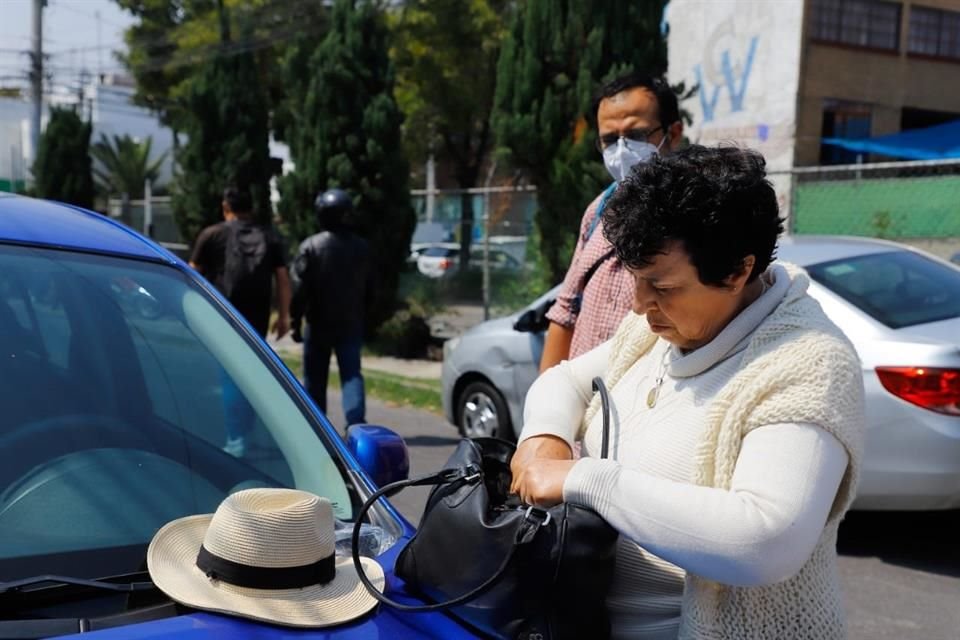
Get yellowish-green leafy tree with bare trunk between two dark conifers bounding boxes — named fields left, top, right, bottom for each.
left=392, top=0, right=508, bottom=267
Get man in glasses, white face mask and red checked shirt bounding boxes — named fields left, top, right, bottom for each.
left=540, top=73, right=683, bottom=372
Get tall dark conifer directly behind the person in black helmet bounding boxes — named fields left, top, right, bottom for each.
left=280, top=0, right=416, bottom=329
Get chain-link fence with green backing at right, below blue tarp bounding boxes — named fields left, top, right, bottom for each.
left=771, top=160, right=960, bottom=258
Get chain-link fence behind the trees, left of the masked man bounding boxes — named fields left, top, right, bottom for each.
left=107, top=186, right=546, bottom=344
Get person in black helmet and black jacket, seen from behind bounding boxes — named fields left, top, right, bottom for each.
left=290, top=189, right=373, bottom=427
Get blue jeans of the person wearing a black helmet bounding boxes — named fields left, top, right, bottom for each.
left=303, top=326, right=366, bottom=426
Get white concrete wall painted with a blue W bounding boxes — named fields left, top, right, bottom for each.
left=665, top=0, right=803, bottom=220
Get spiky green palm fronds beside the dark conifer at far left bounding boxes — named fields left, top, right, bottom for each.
left=90, top=134, right=167, bottom=198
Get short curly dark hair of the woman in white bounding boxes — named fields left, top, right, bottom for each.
left=603, top=145, right=783, bottom=286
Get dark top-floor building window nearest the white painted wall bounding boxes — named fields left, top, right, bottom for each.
left=812, top=0, right=901, bottom=51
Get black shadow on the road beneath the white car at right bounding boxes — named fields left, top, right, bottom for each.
left=837, top=510, right=960, bottom=577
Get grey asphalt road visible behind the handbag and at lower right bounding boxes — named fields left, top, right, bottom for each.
left=330, top=393, right=960, bottom=640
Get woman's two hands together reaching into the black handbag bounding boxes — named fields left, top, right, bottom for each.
left=510, top=436, right=575, bottom=507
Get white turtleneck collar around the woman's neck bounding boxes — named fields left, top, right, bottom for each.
left=668, top=264, right=790, bottom=378
